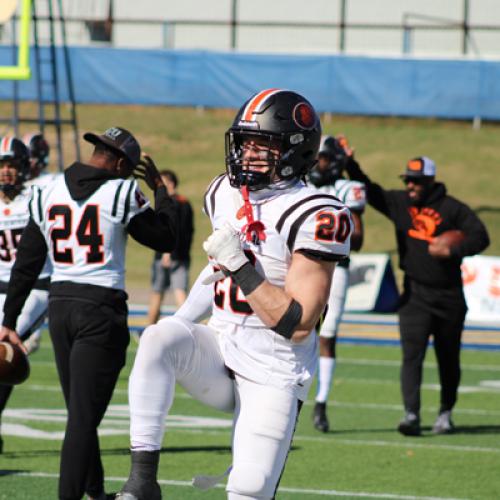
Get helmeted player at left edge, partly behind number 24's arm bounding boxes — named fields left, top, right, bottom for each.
left=0, top=136, right=49, bottom=453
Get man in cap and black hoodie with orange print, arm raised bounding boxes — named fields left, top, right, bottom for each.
left=347, top=154, right=489, bottom=436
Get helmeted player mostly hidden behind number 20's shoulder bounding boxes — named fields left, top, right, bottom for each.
left=308, top=135, right=366, bottom=432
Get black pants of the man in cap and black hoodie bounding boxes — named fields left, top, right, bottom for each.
left=399, top=280, right=467, bottom=415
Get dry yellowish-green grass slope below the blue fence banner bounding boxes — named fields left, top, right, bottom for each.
left=0, top=103, right=500, bottom=288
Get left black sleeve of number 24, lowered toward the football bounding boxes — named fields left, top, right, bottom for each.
left=3, top=219, right=47, bottom=330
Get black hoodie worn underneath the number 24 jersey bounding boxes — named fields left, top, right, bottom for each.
left=3, top=162, right=178, bottom=329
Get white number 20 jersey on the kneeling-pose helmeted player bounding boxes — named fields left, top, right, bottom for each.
left=205, top=175, right=352, bottom=394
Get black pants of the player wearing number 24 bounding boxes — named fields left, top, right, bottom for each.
left=49, top=297, right=130, bottom=500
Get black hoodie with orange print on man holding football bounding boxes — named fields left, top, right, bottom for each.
left=346, top=160, right=490, bottom=288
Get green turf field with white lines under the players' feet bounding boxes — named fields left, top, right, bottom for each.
left=0, top=336, right=500, bottom=500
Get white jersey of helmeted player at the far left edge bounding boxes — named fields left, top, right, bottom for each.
left=0, top=188, right=50, bottom=282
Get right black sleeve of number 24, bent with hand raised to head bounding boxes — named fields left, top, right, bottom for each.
left=127, top=186, right=180, bottom=253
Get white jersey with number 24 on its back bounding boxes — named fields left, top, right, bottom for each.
left=30, top=175, right=149, bottom=290
